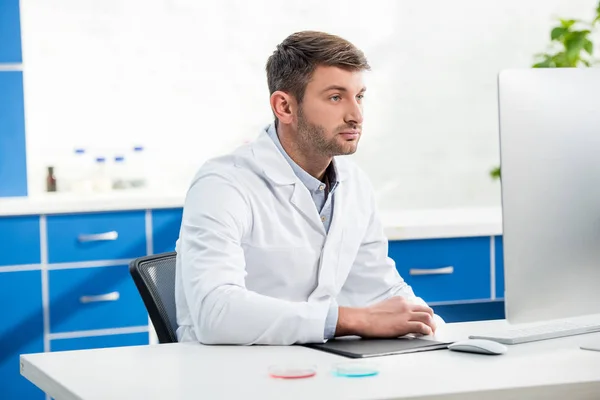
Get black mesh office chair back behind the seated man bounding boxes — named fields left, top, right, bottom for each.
left=129, top=252, right=177, bottom=343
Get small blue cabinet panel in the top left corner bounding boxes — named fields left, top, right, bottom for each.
left=0, top=0, right=21, bottom=63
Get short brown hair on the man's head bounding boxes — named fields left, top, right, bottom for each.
left=266, top=31, right=371, bottom=103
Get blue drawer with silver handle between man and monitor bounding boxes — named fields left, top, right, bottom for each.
left=389, top=237, right=491, bottom=302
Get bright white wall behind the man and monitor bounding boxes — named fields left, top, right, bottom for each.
left=21, top=0, right=597, bottom=210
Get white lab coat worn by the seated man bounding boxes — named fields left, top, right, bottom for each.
left=175, top=126, right=434, bottom=344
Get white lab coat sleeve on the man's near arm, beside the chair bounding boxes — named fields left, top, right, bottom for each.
left=180, top=174, right=332, bottom=345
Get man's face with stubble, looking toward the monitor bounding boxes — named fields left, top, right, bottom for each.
left=297, top=66, right=366, bottom=157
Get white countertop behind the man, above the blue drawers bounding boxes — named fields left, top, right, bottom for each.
left=0, top=190, right=502, bottom=240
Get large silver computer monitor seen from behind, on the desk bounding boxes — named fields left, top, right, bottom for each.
left=499, top=68, right=600, bottom=323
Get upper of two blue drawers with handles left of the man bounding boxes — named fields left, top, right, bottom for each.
left=48, top=211, right=146, bottom=263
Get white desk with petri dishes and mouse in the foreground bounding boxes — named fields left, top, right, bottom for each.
left=21, top=321, right=600, bottom=400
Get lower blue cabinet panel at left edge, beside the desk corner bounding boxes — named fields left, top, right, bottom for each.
left=0, top=271, right=44, bottom=400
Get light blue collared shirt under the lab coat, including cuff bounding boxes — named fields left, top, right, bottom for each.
left=267, top=124, right=338, bottom=339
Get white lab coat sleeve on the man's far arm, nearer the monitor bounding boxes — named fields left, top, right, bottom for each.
left=341, top=181, right=444, bottom=325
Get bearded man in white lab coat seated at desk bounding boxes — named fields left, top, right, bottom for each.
left=176, top=32, right=436, bottom=344
